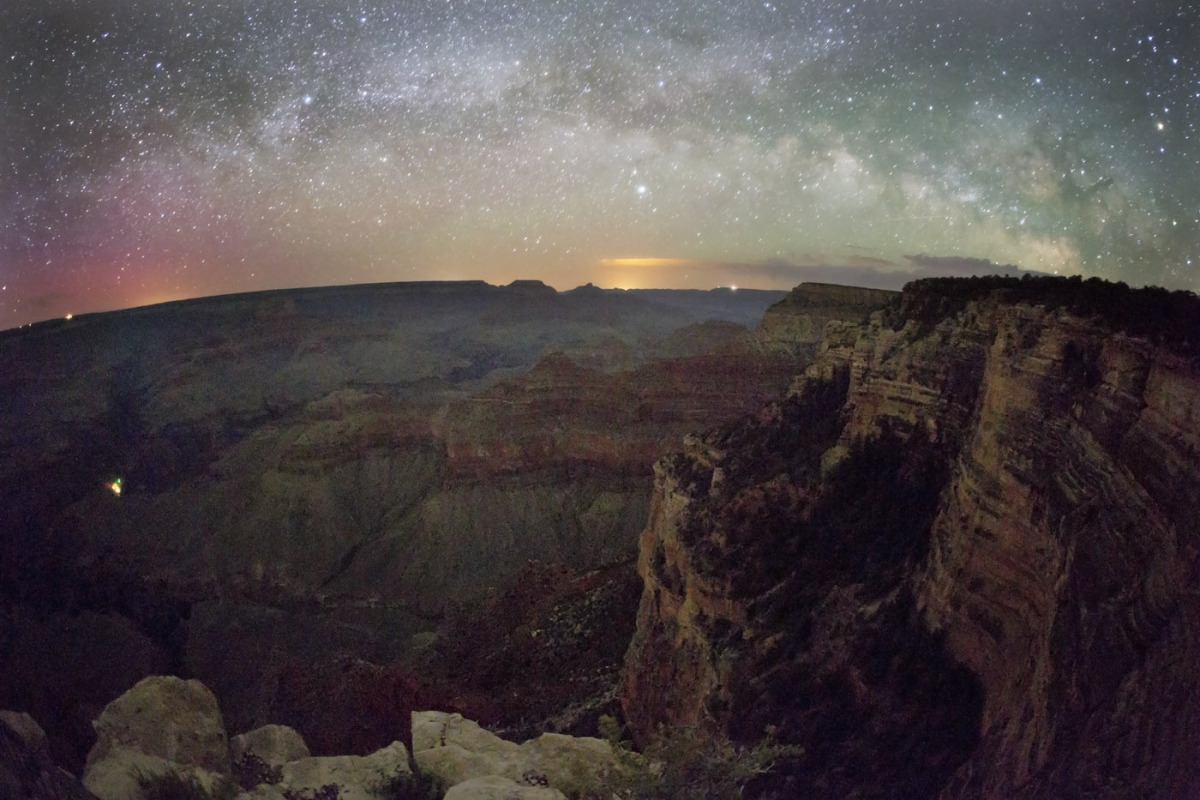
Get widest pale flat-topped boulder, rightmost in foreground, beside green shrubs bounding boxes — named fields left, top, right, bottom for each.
left=413, top=711, right=617, bottom=796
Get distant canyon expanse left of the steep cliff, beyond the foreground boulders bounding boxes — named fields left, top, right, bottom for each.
left=0, top=282, right=897, bottom=765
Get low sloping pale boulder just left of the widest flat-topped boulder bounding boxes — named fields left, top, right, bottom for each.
left=239, top=741, right=412, bottom=800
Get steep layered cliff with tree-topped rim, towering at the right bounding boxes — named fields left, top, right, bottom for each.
left=623, top=278, right=1200, bottom=798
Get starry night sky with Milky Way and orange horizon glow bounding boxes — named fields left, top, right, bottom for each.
left=0, top=0, right=1200, bottom=329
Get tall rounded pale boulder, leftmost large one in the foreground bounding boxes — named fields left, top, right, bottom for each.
left=88, top=675, right=229, bottom=774
